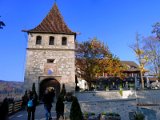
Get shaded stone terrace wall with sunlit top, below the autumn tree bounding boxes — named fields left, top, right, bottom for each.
left=72, top=91, right=136, bottom=120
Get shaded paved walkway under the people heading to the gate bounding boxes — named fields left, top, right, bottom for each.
left=9, top=103, right=56, bottom=120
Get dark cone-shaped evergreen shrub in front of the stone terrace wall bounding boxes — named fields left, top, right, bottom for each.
left=70, top=97, right=83, bottom=120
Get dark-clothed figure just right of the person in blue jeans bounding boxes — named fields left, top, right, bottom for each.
left=56, top=96, right=64, bottom=120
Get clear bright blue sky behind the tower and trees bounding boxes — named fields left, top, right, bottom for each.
left=0, top=0, right=160, bottom=81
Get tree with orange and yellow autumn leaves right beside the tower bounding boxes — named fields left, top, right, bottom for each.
left=76, top=38, right=123, bottom=88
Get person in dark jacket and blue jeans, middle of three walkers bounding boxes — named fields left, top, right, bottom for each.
left=43, top=89, right=53, bottom=120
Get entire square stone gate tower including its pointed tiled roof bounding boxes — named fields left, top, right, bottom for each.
left=24, top=3, right=76, bottom=95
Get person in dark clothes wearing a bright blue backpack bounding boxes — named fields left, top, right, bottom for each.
left=27, top=91, right=36, bottom=120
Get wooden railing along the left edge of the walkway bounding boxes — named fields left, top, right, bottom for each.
left=8, top=100, right=22, bottom=115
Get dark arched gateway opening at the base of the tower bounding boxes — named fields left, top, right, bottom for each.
left=39, top=78, right=61, bottom=99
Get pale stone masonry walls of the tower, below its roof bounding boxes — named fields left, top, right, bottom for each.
left=24, top=33, right=75, bottom=92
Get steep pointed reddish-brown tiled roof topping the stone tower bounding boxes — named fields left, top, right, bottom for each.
left=24, top=3, right=76, bottom=35
